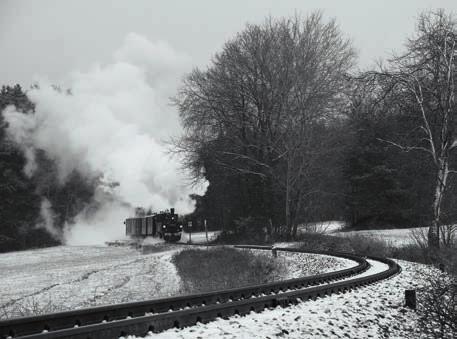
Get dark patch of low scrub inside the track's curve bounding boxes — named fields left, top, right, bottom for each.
left=172, top=247, right=283, bottom=293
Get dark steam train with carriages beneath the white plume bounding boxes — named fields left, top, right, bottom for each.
left=124, top=208, right=182, bottom=241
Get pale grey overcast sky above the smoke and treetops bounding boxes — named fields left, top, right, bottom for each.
left=0, top=0, right=457, bottom=85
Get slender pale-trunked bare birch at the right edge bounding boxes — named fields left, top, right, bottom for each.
left=378, top=10, right=457, bottom=247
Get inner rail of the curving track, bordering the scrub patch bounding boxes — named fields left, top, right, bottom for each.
left=0, top=246, right=368, bottom=338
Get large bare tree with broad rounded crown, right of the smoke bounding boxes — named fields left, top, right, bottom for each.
left=175, top=13, right=355, bottom=239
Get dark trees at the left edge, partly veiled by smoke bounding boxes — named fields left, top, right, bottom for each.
left=0, top=85, right=96, bottom=252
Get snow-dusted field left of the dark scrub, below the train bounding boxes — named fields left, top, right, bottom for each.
left=0, top=246, right=181, bottom=318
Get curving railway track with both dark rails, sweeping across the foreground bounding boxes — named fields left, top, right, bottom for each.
left=0, top=245, right=400, bottom=339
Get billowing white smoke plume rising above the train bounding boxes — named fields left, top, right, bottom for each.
left=4, top=33, right=205, bottom=244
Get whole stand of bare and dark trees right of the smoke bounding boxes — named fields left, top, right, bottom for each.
left=174, top=10, right=457, bottom=246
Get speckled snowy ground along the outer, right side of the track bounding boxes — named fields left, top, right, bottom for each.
left=130, top=261, right=428, bottom=339
